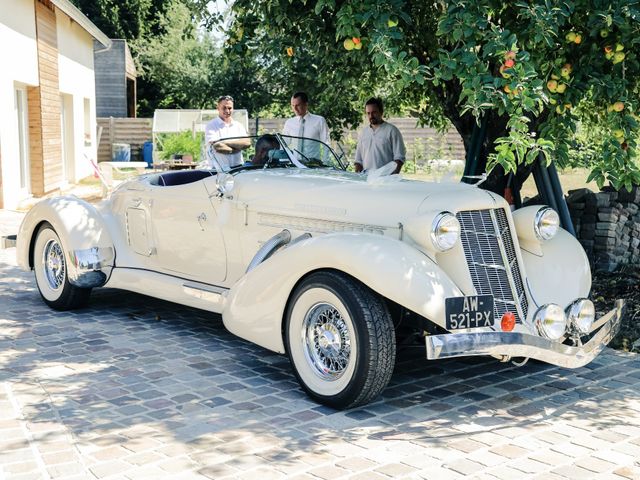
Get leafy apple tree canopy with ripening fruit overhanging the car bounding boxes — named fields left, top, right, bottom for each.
left=227, top=0, right=640, bottom=188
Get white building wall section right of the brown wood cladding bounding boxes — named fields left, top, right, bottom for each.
left=56, top=10, right=97, bottom=182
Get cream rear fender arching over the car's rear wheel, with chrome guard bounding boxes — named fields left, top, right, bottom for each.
left=16, top=197, right=115, bottom=288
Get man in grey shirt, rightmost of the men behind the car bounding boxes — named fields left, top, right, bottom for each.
left=354, top=98, right=406, bottom=173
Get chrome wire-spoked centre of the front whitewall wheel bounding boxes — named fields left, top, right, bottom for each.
left=302, top=303, right=351, bottom=381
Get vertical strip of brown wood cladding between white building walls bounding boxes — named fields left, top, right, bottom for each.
left=32, top=2, right=64, bottom=195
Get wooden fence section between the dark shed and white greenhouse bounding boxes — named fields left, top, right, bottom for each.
left=98, top=117, right=152, bottom=162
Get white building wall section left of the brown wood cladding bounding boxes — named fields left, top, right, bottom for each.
left=0, top=0, right=38, bottom=209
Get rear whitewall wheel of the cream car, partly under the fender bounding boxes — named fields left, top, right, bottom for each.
left=33, top=224, right=91, bottom=311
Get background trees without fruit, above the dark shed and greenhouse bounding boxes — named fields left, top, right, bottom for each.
left=73, top=0, right=272, bottom=116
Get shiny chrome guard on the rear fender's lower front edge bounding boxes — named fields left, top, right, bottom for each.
left=67, top=247, right=115, bottom=288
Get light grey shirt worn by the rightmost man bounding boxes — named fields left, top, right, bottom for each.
left=355, top=122, right=406, bottom=170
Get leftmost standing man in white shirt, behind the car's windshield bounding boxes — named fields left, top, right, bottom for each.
left=204, top=95, right=251, bottom=170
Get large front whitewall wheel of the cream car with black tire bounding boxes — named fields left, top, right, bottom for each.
left=285, top=271, right=396, bottom=409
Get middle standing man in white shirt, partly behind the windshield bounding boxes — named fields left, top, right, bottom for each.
left=282, top=92, right=329, bottom=158
